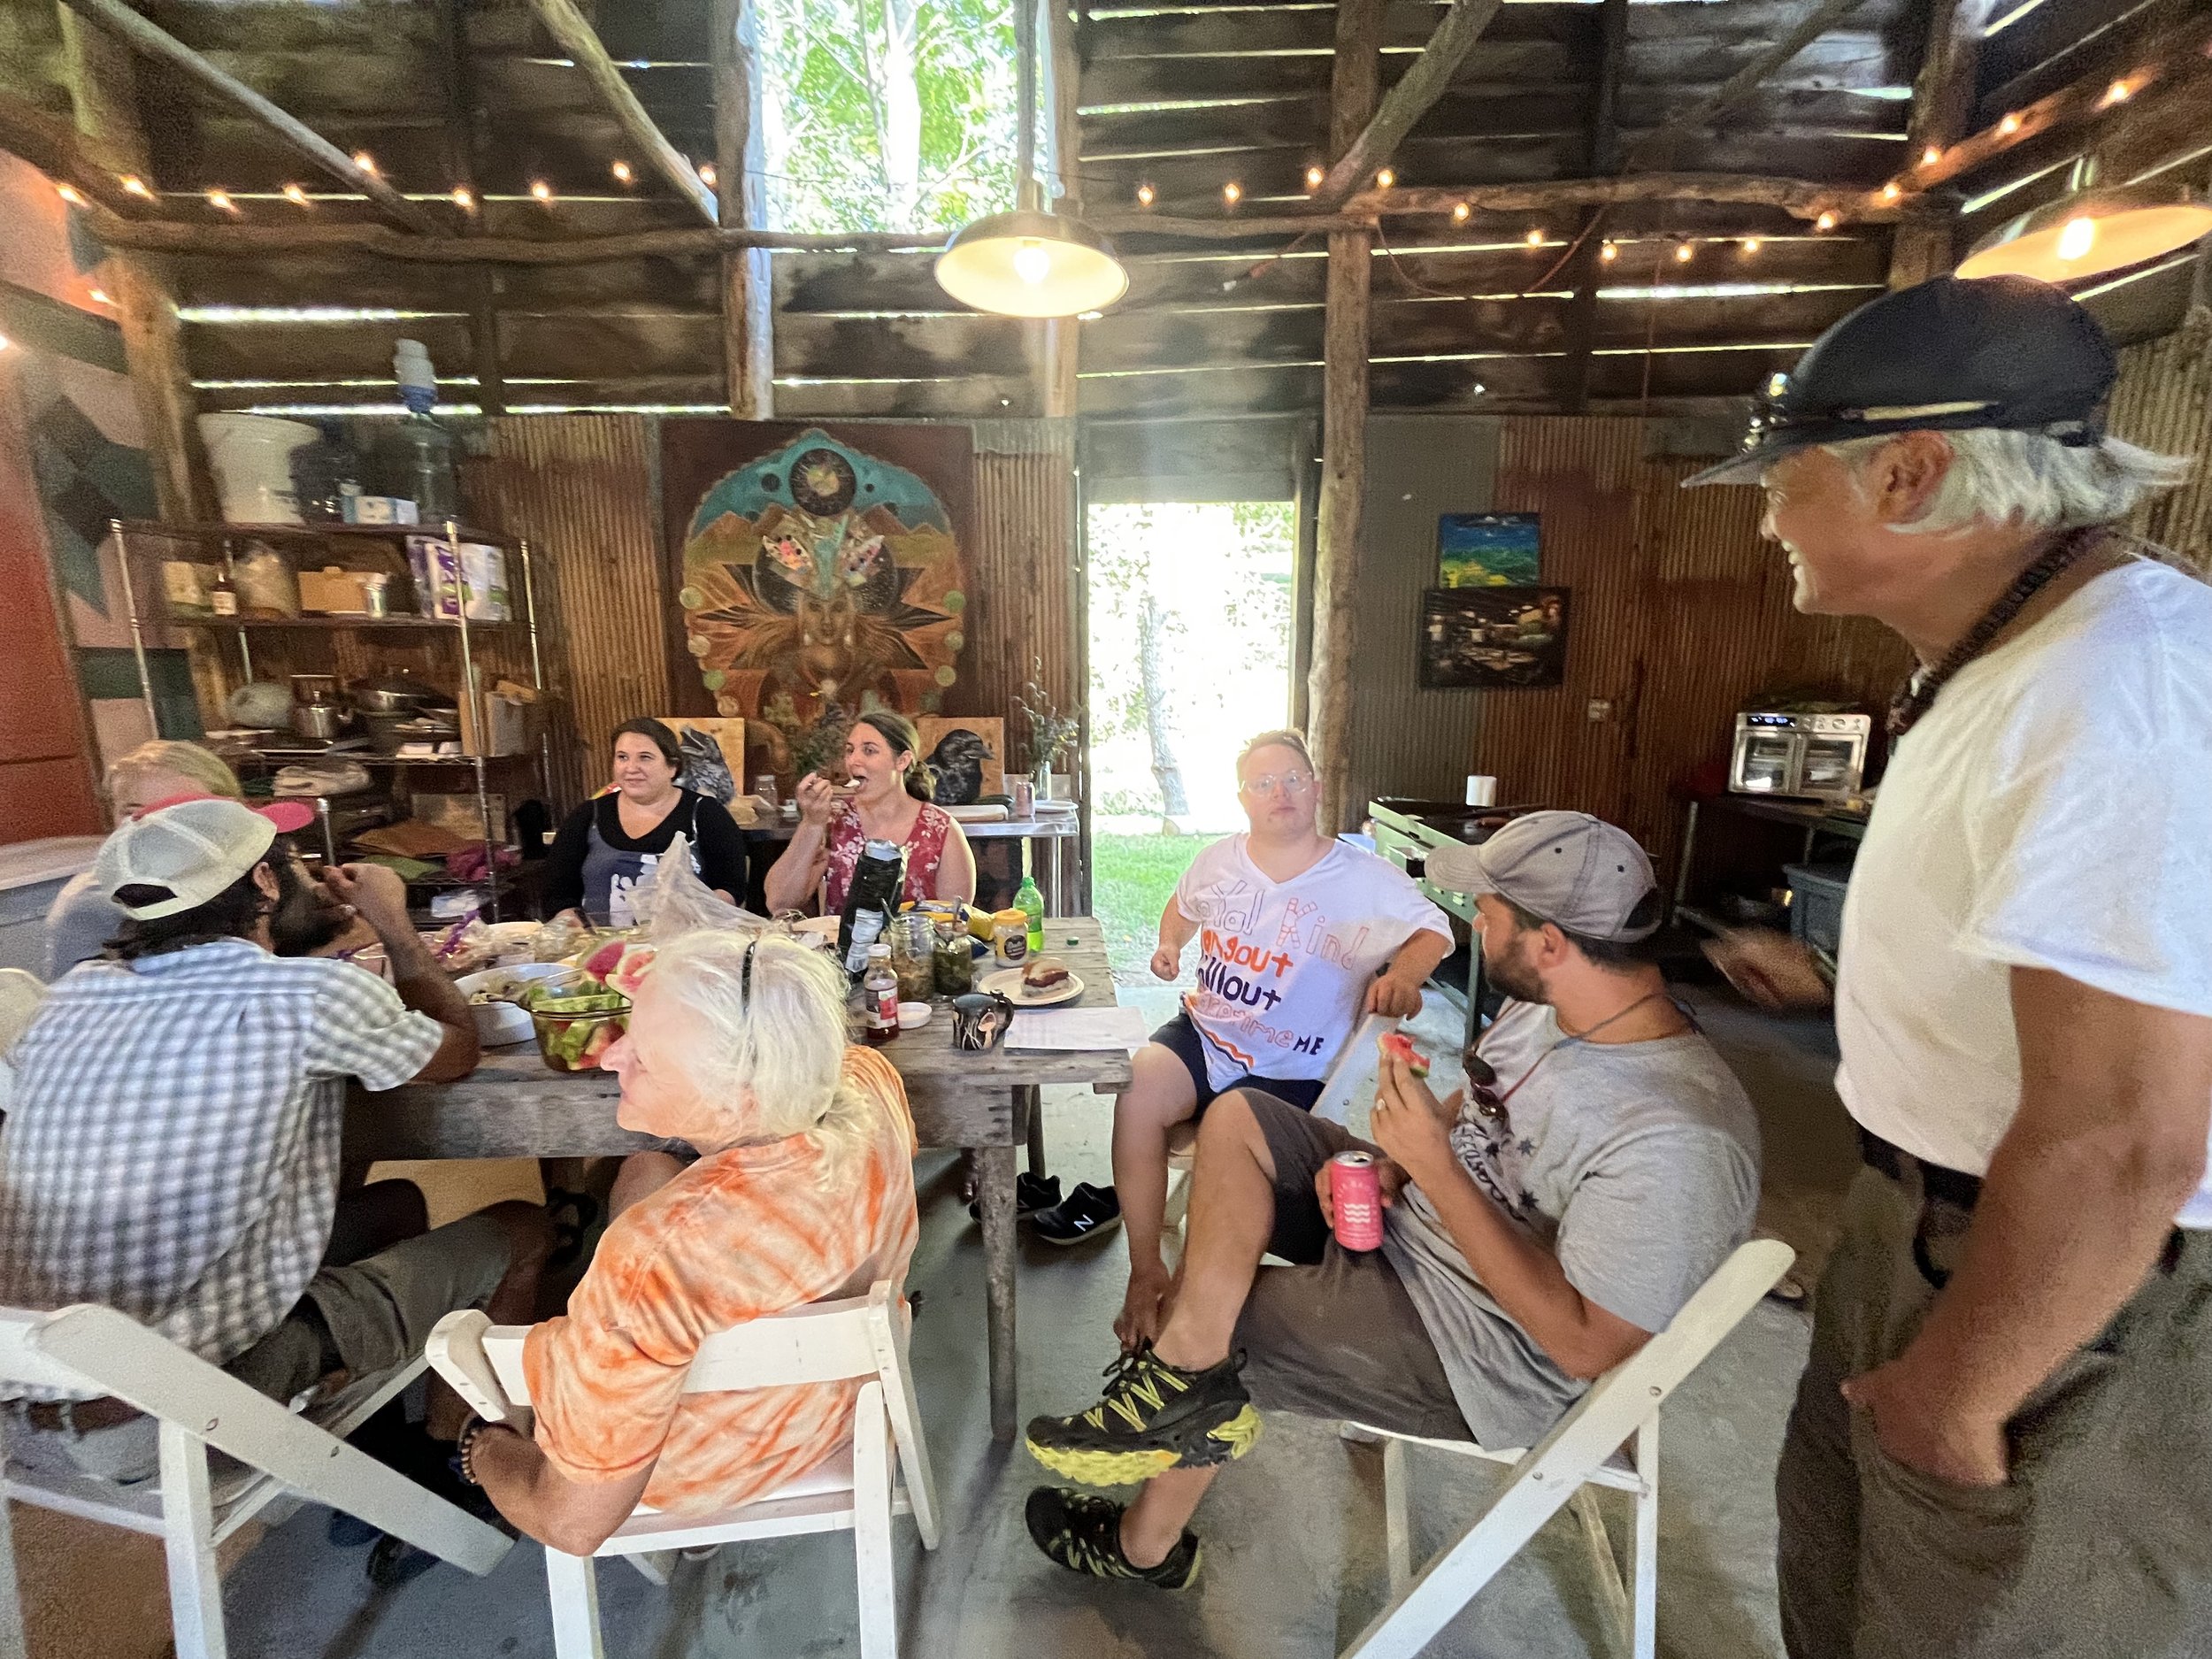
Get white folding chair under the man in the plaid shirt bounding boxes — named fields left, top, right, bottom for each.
left=0, top=1305, right=513, bottom=1659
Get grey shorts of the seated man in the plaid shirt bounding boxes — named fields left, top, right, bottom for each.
left=9, top=1215, right=509, bottom=1485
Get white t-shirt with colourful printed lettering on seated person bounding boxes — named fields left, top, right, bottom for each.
left=1175, top=836, right=1451, bottom=1088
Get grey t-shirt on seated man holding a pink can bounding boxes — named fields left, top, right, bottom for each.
left=1383, top=1002, right=1759, bottom=1449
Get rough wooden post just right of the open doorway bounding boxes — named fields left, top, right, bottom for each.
left=1308, top=0, right=1383, bottom=836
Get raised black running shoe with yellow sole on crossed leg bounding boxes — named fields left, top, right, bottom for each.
left=1029, top=1343, right=1259, bottom=1486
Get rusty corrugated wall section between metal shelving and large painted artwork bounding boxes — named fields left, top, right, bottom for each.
left=472, top=416, right=675, bottom=808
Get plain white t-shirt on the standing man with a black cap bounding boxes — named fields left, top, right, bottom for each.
left=1836, top=560, right=2212, bottom=1228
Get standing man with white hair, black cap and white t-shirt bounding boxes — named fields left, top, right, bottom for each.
left=1690, top=277, right=2212, bottom=1659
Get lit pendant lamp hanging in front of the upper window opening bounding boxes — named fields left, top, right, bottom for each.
left=938, top=0, right=1128, bottom=317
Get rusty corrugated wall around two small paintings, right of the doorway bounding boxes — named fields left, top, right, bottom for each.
left=1354, top=416, right=1907, bottom=879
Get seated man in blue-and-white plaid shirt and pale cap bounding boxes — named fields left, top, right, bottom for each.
left=0, top=799, right=551, bottom=1478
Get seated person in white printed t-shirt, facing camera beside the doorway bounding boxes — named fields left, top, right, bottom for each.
left=1040, top=733, right=1454, bottom=1349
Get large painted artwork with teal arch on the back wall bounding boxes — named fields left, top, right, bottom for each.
left=662, top=420, right=973, bottom=792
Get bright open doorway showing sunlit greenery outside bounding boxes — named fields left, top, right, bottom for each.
left=1087, top=503, right=1296, bottom=985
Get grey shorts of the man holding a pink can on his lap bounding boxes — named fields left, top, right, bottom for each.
left=1237, top=1088, right=1476, bottom=1440
